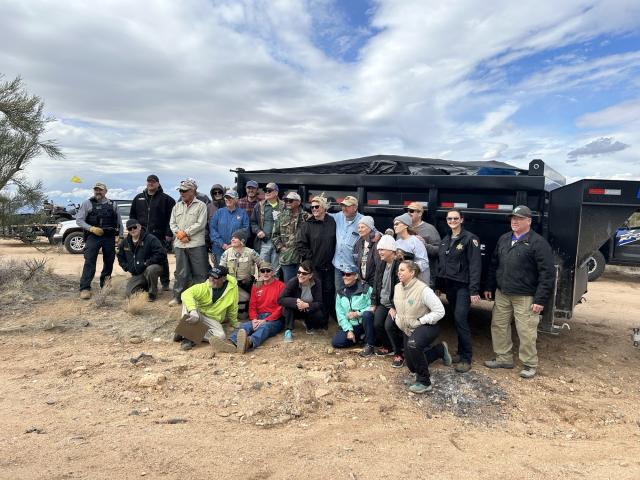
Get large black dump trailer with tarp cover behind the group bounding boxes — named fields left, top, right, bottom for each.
left=234, top=155, right=640, bottom=333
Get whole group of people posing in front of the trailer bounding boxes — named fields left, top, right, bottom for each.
left=77, top=175, right=555, bottom=393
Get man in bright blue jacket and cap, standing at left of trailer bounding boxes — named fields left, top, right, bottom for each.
left=209, top=190, right=249, bottom=264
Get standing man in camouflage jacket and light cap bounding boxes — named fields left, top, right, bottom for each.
left=272, top=192, right=307, bottom=283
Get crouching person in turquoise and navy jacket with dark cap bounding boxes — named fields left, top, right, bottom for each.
left=331, top=267, right=376, bottom=357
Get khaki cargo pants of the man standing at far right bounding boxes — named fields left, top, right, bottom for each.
left=491, top=289, right=540, bottom=368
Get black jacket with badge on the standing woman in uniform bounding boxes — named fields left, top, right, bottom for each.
left=436, top=229, right=482, bottom=295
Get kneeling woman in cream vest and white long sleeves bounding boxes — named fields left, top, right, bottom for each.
left=393, top=260, right=451, bottom=393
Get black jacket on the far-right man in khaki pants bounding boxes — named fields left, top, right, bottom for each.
left=487, top=230, right=555, bottom=305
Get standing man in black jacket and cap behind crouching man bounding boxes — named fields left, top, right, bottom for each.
left=129, top=175, right=176, bottom=291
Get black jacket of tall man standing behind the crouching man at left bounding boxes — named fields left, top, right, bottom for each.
left=129, top=187, right=176, bottom=241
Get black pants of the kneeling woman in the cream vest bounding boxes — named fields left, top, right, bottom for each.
left=404, top=325, right=444, bottom=385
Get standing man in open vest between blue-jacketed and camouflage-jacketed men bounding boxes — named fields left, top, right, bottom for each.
left=251, top=182, right=284, bottom=275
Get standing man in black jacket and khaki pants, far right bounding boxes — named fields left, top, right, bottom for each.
left=484, top=205, right=555, bottom=378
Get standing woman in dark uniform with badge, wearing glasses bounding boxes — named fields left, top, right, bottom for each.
left=436, top=208, right=482, bottom=373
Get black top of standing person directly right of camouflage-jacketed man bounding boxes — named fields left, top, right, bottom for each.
left=296, top=213, right=336, bottom=269
